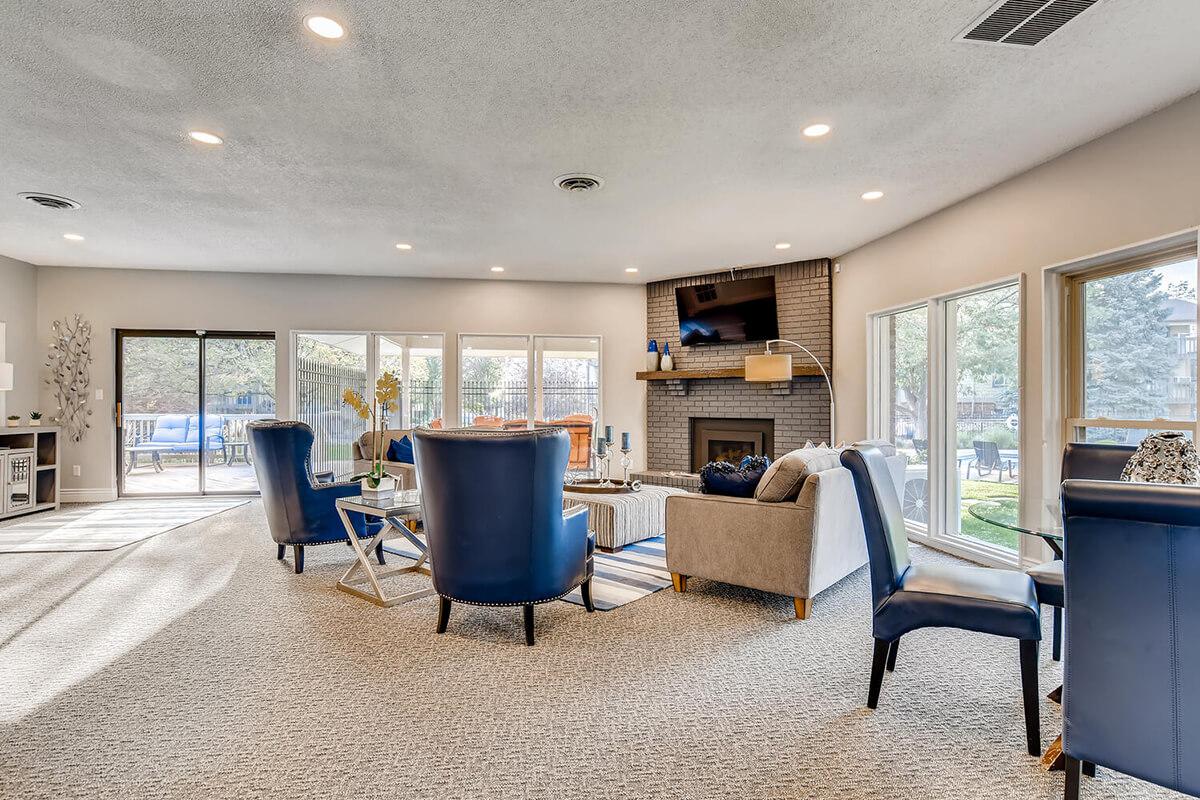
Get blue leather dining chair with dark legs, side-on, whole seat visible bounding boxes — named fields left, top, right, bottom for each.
left=841, top=446, right=1042, bottom=756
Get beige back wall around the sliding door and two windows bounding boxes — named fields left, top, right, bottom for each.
left=37, top=267, right=646, bottom=500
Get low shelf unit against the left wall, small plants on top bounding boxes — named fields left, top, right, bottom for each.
left=0, top=426, right=62, bottom=519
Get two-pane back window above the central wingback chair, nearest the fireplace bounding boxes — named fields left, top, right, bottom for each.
left=458, top=333, right=600, bottom=427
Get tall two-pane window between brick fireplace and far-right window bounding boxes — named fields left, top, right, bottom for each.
left=871, top=281, right=1021, bottom=564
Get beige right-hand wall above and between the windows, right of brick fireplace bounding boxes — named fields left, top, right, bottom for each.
left=833, top=95, right=1200, bottom=513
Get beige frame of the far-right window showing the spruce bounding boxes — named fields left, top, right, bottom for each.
left=1061, top=244, right=1200, bottom=445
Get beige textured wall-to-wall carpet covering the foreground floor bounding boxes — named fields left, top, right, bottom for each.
left=0, top=501, right=1176, bottom=800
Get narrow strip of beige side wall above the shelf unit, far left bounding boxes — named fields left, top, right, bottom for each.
left=0, top=255, right=42, bottom=416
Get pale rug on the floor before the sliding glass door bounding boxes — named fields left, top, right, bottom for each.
left=0, top=498, right=250, bottom=553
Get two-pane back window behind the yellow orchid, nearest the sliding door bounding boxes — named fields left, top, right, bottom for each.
left=294, top=332, right=443, bottom=475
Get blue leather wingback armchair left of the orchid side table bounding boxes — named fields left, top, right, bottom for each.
left=246, top=420, right=384, bottom=573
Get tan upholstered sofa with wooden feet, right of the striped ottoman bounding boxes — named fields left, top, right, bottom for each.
left=666, top=456, right=907, bottom=619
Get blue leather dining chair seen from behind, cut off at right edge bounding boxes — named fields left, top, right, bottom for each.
left=1062, top=480, right=1200, bottom=800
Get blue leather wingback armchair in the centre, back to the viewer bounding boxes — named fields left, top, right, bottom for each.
left=413, top=428, right=595, bottom=645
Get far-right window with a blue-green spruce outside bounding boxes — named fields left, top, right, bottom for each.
left=1067, top=247, right=1196, bottom=444
